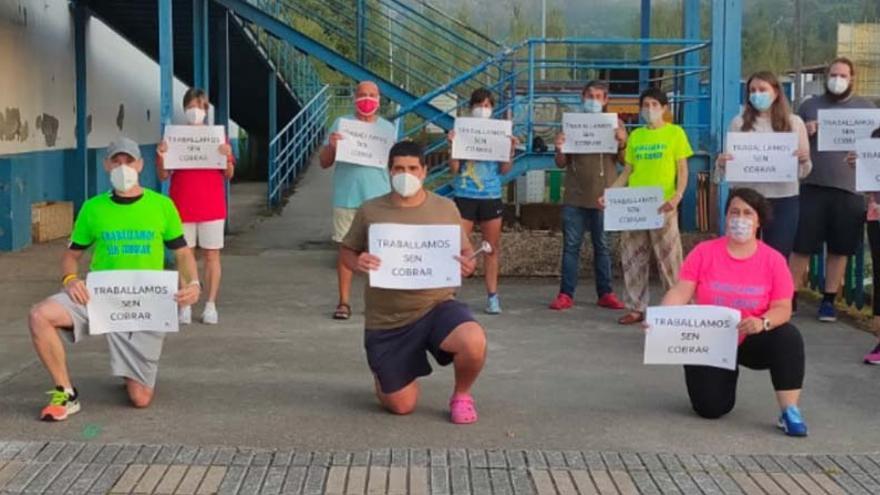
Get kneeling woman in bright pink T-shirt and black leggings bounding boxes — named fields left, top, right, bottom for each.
left=662, top=188, right=807, bottom=437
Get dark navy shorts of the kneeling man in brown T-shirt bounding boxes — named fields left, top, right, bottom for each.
left=364, top=300, right=475, bottom=394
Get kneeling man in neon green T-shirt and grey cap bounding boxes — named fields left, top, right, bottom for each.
left=29, top=137, right=201, bottom=421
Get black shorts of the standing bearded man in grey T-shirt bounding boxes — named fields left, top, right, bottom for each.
left=794, top=184, right=865, bottom=256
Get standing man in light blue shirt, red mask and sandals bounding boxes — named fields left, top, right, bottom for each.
left=320, top=81, right=394, bottom=320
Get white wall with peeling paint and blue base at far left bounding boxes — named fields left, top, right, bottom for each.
left=0, top=0, right=238, bottom=251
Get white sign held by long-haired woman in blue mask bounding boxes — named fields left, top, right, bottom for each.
left=725, top=132, right=798, bottom=182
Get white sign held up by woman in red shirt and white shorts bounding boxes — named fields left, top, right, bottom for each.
left=163, top=125, right=227, bottom=170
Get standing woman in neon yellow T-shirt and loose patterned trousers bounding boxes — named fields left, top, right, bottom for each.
left=602, top=88, right=694, bottom=325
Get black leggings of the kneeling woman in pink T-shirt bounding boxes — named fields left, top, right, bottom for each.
left=684, top=323, right=804, bottom=419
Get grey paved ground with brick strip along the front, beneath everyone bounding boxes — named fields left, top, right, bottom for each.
left=0, top=162, right=880, bottom=494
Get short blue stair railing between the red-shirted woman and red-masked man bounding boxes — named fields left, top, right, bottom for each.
left=266, top=85, right=330, bottom=208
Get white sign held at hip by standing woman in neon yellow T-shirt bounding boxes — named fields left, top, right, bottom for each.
left=605, top=187, right=663, bottom=232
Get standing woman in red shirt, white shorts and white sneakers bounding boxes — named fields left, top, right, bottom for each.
left=156, top=88, right=235, bottom=325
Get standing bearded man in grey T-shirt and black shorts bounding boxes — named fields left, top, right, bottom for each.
left=791, top=58, right=876, bottom=321
